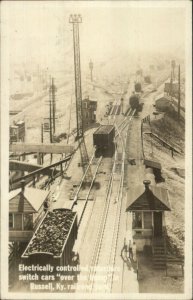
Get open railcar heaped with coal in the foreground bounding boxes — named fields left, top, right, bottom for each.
left=22, top=208, right=78, bottom=266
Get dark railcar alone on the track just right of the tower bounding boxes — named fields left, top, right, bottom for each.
left=93, top=125, right=115, bottom=157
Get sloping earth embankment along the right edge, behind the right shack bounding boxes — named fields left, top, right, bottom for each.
left=146, top=114, right=185, bottom=256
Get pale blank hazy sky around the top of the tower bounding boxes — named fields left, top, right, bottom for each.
left=2, top=1, right=188, bottom=73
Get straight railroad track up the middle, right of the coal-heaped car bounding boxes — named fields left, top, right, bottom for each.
left=83, top=111, right=135, bottom=292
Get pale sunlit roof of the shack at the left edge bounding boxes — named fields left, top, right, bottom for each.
left=9, top=187, right=49, bottom=213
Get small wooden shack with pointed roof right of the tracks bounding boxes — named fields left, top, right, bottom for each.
left=126, top=180, right=171, bottom=251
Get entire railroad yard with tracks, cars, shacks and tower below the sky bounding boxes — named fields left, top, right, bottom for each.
left=6, top=3, right=186, bottom=295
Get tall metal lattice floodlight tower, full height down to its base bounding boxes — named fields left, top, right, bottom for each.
left=69, top=15, right=92, bottom=182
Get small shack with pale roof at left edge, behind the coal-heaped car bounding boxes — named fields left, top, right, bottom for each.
left=9, top=187, right=49, bottom=242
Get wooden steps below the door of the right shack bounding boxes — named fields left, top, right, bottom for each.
left=153, top=238, right=166, bottom=270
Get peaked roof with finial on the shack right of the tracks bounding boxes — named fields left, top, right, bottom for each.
left=126, top=185, right=171, bottom=211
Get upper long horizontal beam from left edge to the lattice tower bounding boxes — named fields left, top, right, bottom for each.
left=9, top=143, right=74, bottom=154
